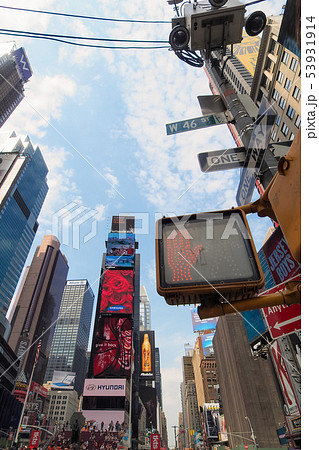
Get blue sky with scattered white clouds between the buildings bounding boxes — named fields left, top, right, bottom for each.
left=0, top=0, right=296, bottom=446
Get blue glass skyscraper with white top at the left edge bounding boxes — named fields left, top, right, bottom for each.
left=0, top=132, right=48, bottom=337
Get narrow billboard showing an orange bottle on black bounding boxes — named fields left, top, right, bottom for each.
left=140, top=331, right=155, bottom=380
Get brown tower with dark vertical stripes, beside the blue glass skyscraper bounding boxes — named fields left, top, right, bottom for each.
left=8, top=236, right=69, bottom=385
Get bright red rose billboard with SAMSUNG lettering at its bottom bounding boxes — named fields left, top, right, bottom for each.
left=100, top=269, right=134, bottom=314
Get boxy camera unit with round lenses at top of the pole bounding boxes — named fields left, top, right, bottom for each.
left=169, top=0, right=266, bottom=52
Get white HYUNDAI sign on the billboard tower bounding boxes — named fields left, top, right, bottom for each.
left=83, top=378, right=126, bottom=397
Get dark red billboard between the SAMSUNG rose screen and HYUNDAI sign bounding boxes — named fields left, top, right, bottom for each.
left=91, top=317, right=133, bottom=378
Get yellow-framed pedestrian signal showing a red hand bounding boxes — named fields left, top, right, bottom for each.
left=156, top=208, right=264, bottom=305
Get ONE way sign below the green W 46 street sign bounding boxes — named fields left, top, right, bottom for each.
left=197, top=147, right=246, bottom=173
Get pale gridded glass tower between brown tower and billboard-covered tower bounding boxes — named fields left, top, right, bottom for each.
left=45, top=280, right=94, bottom=394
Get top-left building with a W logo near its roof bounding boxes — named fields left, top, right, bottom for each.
left=0, top=42, right=32, bottom=127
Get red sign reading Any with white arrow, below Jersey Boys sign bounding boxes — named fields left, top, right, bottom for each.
left=262, top=275, right=301, bottom=339
